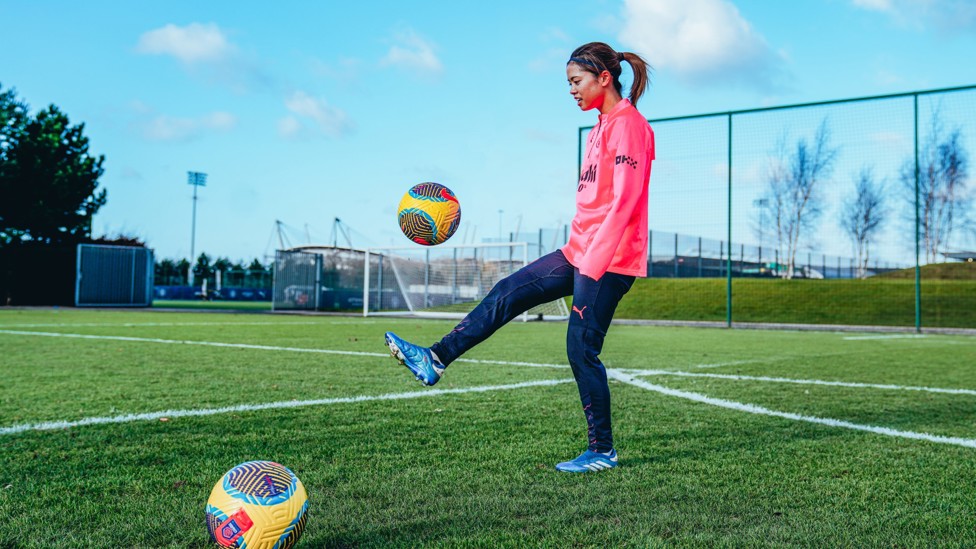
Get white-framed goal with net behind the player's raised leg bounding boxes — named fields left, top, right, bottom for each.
left=363, top=242, right=569, bottom=320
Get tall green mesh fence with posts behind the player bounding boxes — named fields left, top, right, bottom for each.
left=579, top=86, right=976, bottom=329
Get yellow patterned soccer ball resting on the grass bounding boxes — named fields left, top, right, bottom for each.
left=206, top=461, right=308, bottom=549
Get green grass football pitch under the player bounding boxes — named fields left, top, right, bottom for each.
left=0, top=309, right=976, bottom=548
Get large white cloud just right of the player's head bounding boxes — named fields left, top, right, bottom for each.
left=620, top=0, right=782, bottom=89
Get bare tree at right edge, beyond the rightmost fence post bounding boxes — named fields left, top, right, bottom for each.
left=901, top=111, right=974, bottom=263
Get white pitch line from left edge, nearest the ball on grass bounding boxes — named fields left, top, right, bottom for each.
left=0, top=379, right=573, bottom=436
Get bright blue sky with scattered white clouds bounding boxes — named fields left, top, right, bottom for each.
left=0, top=0, right=976, bottom=263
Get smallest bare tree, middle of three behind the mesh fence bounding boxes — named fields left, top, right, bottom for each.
left=840, top=166, right=888, bottom=278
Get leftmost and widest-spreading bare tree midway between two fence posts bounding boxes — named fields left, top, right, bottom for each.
left=762, top=118, right=837, bottom=278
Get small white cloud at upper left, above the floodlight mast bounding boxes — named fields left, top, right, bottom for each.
left=136, top=23, right=236, bottom=64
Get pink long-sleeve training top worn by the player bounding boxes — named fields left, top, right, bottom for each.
left=562, top=99, right=654, bottom=280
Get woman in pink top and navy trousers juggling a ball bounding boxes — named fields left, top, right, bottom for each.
left=386, top=42, right=654, bottom=473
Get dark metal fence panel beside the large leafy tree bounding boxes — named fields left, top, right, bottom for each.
left=75, top=244, right=153, bottom=307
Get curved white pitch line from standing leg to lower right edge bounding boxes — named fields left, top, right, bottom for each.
left=607, top=370, right=976, bottom=448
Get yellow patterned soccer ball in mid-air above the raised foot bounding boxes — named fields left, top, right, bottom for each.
left=397, top=183, right=461, bottom=246
